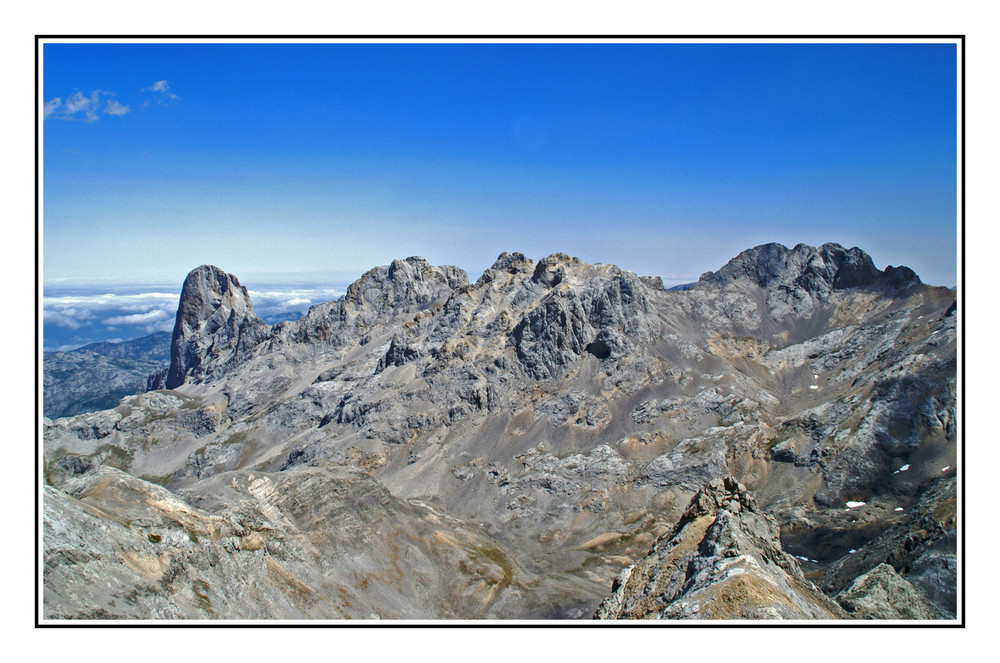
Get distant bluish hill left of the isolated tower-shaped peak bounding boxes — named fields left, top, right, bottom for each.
left=42, top=332, right=170, bottom=419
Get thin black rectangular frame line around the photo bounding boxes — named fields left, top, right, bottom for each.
left=34, top=34, right=966, bottom=629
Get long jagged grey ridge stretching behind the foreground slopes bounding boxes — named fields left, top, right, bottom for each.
left=45, top=245, right=955, bottom=617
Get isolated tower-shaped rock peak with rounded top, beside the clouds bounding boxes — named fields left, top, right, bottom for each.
left=165, top=265, right=270, bottom=389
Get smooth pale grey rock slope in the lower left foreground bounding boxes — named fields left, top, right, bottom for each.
left=43, top=467, right=529, bottom=619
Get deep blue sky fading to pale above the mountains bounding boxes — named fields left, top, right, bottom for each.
left=43, top=43, right=958, bottom=289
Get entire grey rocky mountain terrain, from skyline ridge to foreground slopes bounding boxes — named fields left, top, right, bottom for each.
left=41, top=244, right=961, bottom=620
